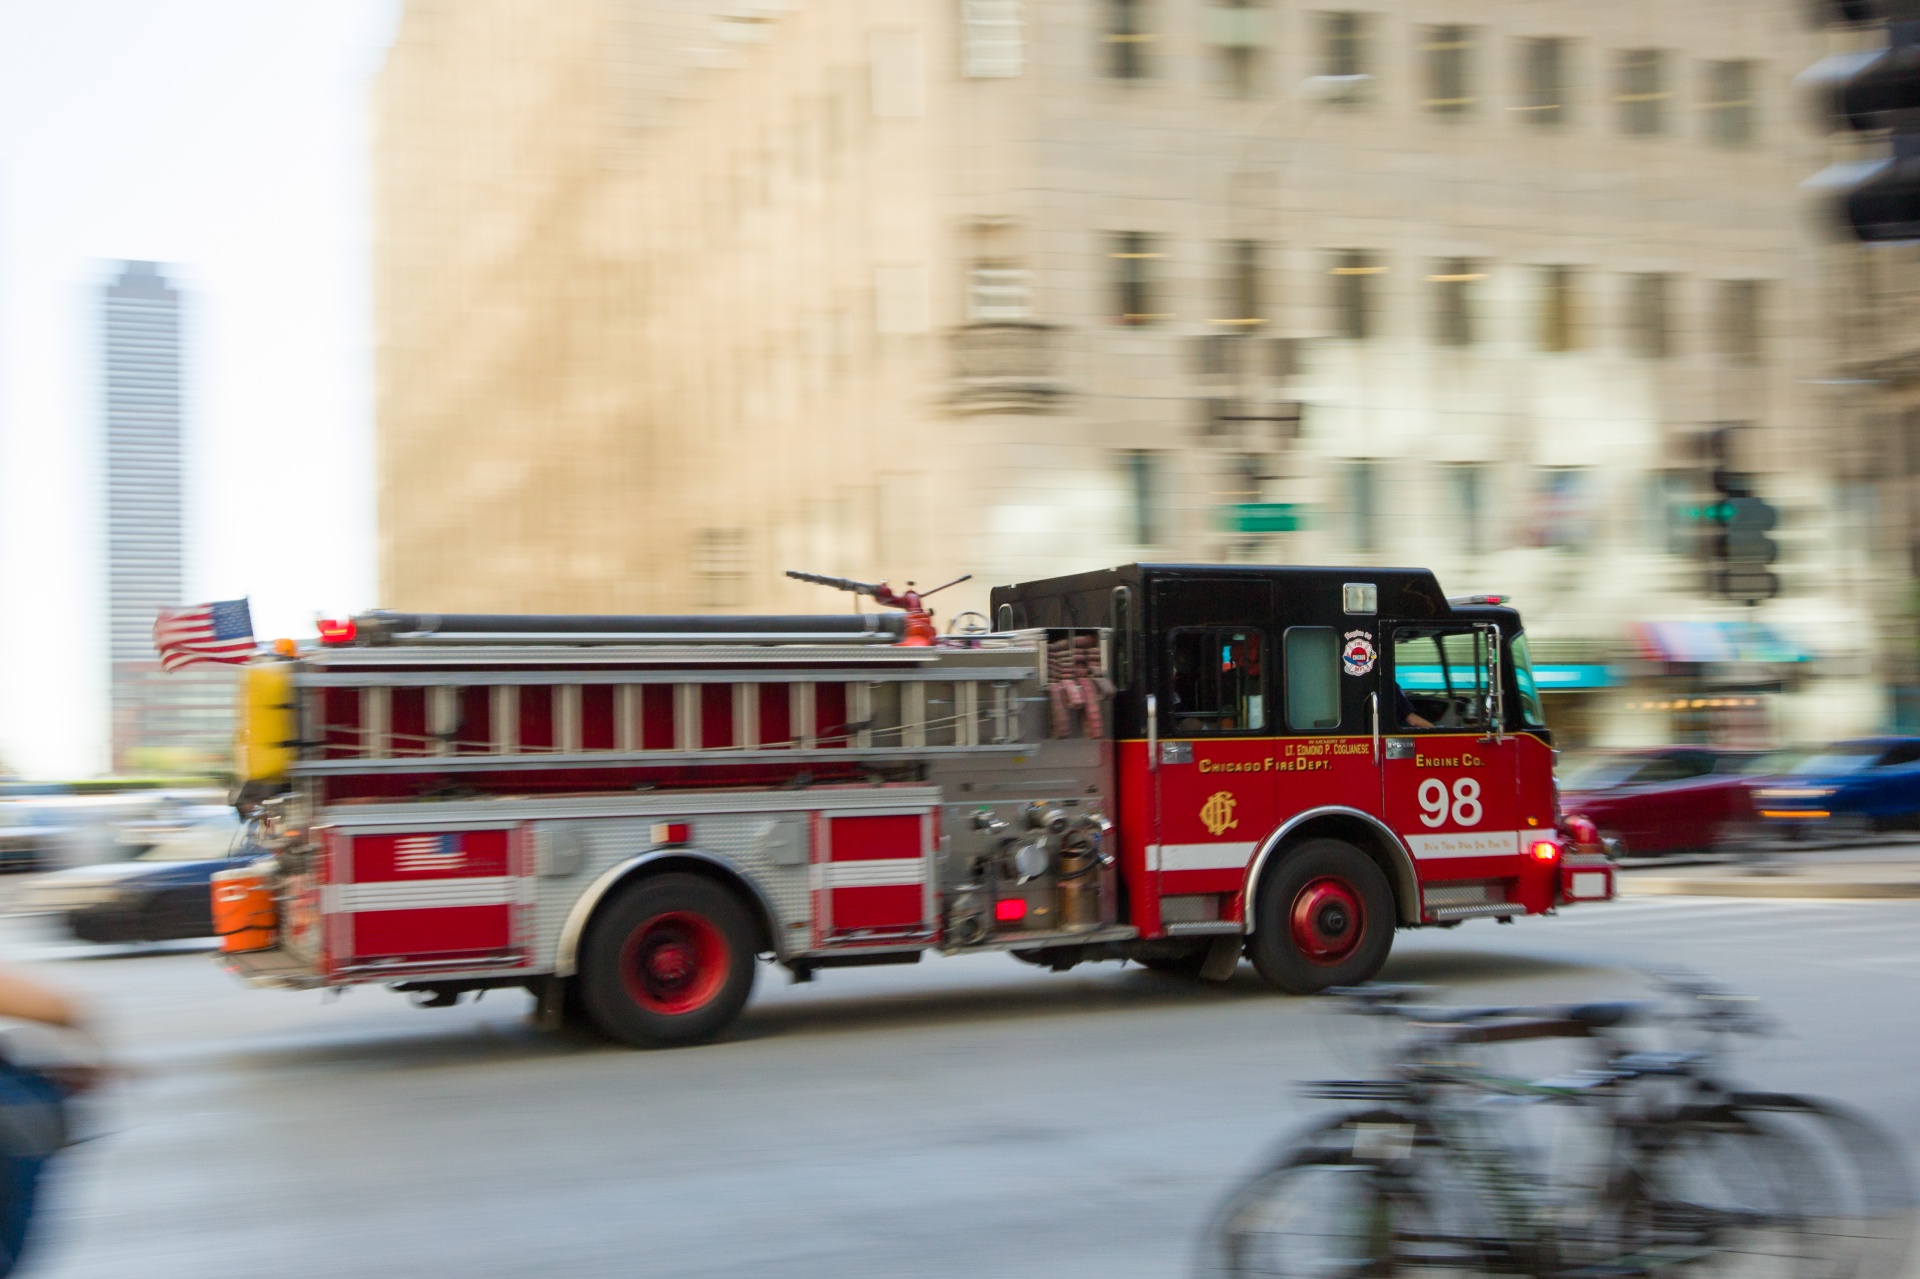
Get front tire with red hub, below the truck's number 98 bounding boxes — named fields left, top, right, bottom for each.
left=1248, top=839, right=1394, bottom=995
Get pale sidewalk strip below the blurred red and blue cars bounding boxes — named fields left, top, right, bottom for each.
left=1620, top=843, right=1920, bottom=899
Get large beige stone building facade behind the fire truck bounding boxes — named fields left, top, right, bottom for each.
left=376, top=0, right=1884, bottom=741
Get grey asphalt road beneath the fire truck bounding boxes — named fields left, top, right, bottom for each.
left=11, top=899, right=1920, bottom=1279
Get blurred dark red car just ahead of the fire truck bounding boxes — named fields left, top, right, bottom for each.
left=1559, top=745, right=1764, bottom=857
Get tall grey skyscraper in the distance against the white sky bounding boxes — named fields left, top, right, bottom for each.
left=102, top=261, right=232, bottom=772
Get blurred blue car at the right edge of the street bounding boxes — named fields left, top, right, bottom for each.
left=1753, top=737, right=1920, bottom=839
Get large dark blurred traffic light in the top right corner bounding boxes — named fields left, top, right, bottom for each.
left=1801, top=0, right=1920, bottom=244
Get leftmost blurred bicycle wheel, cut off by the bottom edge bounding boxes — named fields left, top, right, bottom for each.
left=1202, top=1120, right=1486, bottom=1279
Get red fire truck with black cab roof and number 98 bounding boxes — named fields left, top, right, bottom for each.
left=215, top=565, right=1613, bottom=1045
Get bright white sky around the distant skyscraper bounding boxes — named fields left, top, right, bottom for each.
left=0, top=0, right=399, bottom=776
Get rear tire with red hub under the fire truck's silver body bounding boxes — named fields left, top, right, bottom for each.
left=580, top=874, right=758, bottom=1049
